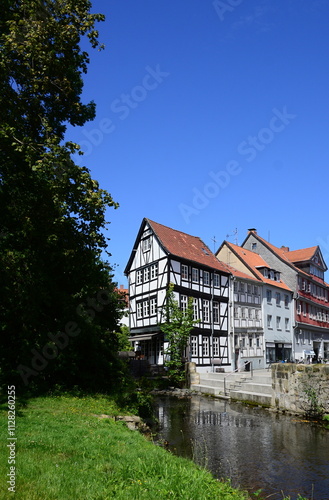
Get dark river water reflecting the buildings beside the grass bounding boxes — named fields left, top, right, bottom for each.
left=155, top=396, right=329, bottom=500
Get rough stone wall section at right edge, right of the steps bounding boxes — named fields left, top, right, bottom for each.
left=272, top=363, right=329, bottom=413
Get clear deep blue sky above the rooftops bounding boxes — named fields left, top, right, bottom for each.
left=67, top=0, right=329, bottom=285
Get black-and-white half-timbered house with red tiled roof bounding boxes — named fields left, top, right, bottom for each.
left=125, top=218, right=231, bottom=372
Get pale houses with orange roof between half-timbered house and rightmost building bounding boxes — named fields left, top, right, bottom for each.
left=216, top=241, right=293, bottom=369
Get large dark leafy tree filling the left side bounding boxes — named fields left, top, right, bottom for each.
left=0, top=0, right=121, bottom=389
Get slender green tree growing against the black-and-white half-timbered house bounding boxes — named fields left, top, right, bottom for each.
left=160, top=283, right=197, bottom=386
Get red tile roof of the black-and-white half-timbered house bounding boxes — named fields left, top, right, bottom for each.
left=145, top=219, right=230, bottom=274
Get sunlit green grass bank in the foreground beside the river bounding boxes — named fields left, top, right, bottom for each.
left=0, top=396, right=247, bottom=500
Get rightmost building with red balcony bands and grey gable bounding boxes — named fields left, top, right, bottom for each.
left=242, top=229, right=329, bottom=362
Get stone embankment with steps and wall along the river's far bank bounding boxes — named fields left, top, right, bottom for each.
left=186, top=363, right=329, bottom=414
